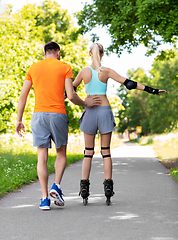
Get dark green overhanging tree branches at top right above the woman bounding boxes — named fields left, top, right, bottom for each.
left=77, top=0, right=178, bottom=55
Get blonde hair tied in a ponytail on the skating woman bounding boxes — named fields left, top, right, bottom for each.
left=90, top=43, right=104, bottom=72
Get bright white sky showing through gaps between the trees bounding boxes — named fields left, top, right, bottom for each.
left=0, top=0, right=177, bottom=94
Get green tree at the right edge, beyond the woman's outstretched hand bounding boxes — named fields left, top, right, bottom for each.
left=148, top=52, right=178, bottom=133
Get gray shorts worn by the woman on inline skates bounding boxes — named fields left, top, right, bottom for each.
left=79, top=106, right=116, bottom=135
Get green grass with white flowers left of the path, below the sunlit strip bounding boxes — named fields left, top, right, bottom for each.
left=0, top=149, right=83, bottom=198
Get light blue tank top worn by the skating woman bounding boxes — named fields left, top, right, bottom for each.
left=85, top=66, right=107, bottom=95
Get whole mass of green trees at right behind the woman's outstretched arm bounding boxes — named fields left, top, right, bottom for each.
left=118, top=52, right=178, bottom=135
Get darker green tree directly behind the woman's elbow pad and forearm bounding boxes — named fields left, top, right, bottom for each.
left=118, top=68, right=150, bottom=135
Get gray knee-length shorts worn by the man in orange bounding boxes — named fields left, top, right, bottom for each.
left=31, top=112, right=69, bottom=148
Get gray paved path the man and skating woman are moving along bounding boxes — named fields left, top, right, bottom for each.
left=0, top=144, right=178, bottom=240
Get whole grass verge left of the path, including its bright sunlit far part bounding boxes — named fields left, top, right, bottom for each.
left=0, top=134, right=121, bottom=198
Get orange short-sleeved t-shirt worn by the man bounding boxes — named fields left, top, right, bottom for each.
left=25, top=58, right=73, bottom=114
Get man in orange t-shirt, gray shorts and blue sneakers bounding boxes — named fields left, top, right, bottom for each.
left=16, top=42, right=100, bottom=210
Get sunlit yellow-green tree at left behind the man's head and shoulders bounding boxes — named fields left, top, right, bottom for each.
left=0, top=0, right=87, bottom=131
